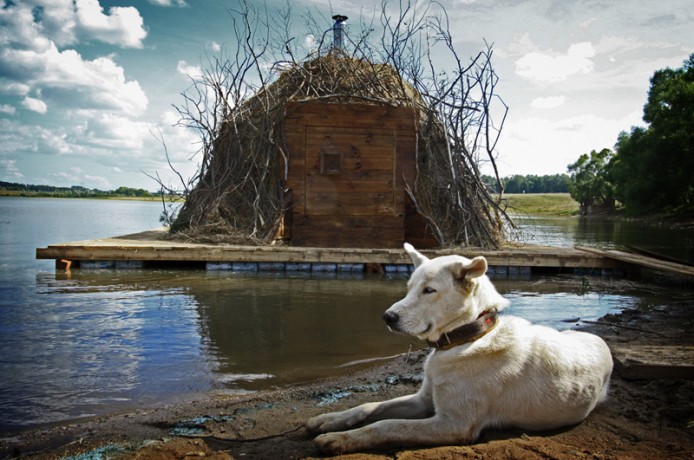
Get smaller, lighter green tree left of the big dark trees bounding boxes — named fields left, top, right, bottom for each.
left=568, top=149, right=615, bottom=214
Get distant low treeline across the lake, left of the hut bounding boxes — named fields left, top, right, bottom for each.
left=0, top=181, right=157, bottom=198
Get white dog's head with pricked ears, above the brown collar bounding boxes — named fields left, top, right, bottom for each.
left=383, top=243, right=508, bottom=341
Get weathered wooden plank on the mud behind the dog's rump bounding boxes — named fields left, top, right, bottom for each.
left=610, top=344, right=694, bottom=380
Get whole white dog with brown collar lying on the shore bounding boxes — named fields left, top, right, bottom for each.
left=306, top=243, right=612, bottom=453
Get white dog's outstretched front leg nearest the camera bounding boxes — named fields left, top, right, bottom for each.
left=315, top=415, right=482, bottom=454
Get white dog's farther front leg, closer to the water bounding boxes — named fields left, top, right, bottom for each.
left=306, top=384, right=434, bottom=433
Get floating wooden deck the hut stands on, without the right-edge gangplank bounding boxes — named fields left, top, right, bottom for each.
left=36, top=229, right=623, bottom=270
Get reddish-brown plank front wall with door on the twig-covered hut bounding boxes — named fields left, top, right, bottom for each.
left=284, top=101, right=437, bottom=248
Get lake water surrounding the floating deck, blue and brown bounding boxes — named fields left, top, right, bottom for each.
left=0, top=197, right=692, bottom=432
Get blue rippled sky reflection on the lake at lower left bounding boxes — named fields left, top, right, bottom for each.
left=0, top=274, right=209, bottom=427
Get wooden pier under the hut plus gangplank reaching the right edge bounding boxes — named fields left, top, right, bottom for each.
left=36, top=228, right=694, bottom=276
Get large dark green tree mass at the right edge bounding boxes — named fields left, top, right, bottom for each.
left=609, top=54, right=694, bottom=214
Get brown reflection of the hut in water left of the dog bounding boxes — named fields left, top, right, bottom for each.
left=191, top=275, right=418, bottom=389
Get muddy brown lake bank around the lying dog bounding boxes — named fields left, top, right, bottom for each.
left=0, top=278, right=694, bottom=460
